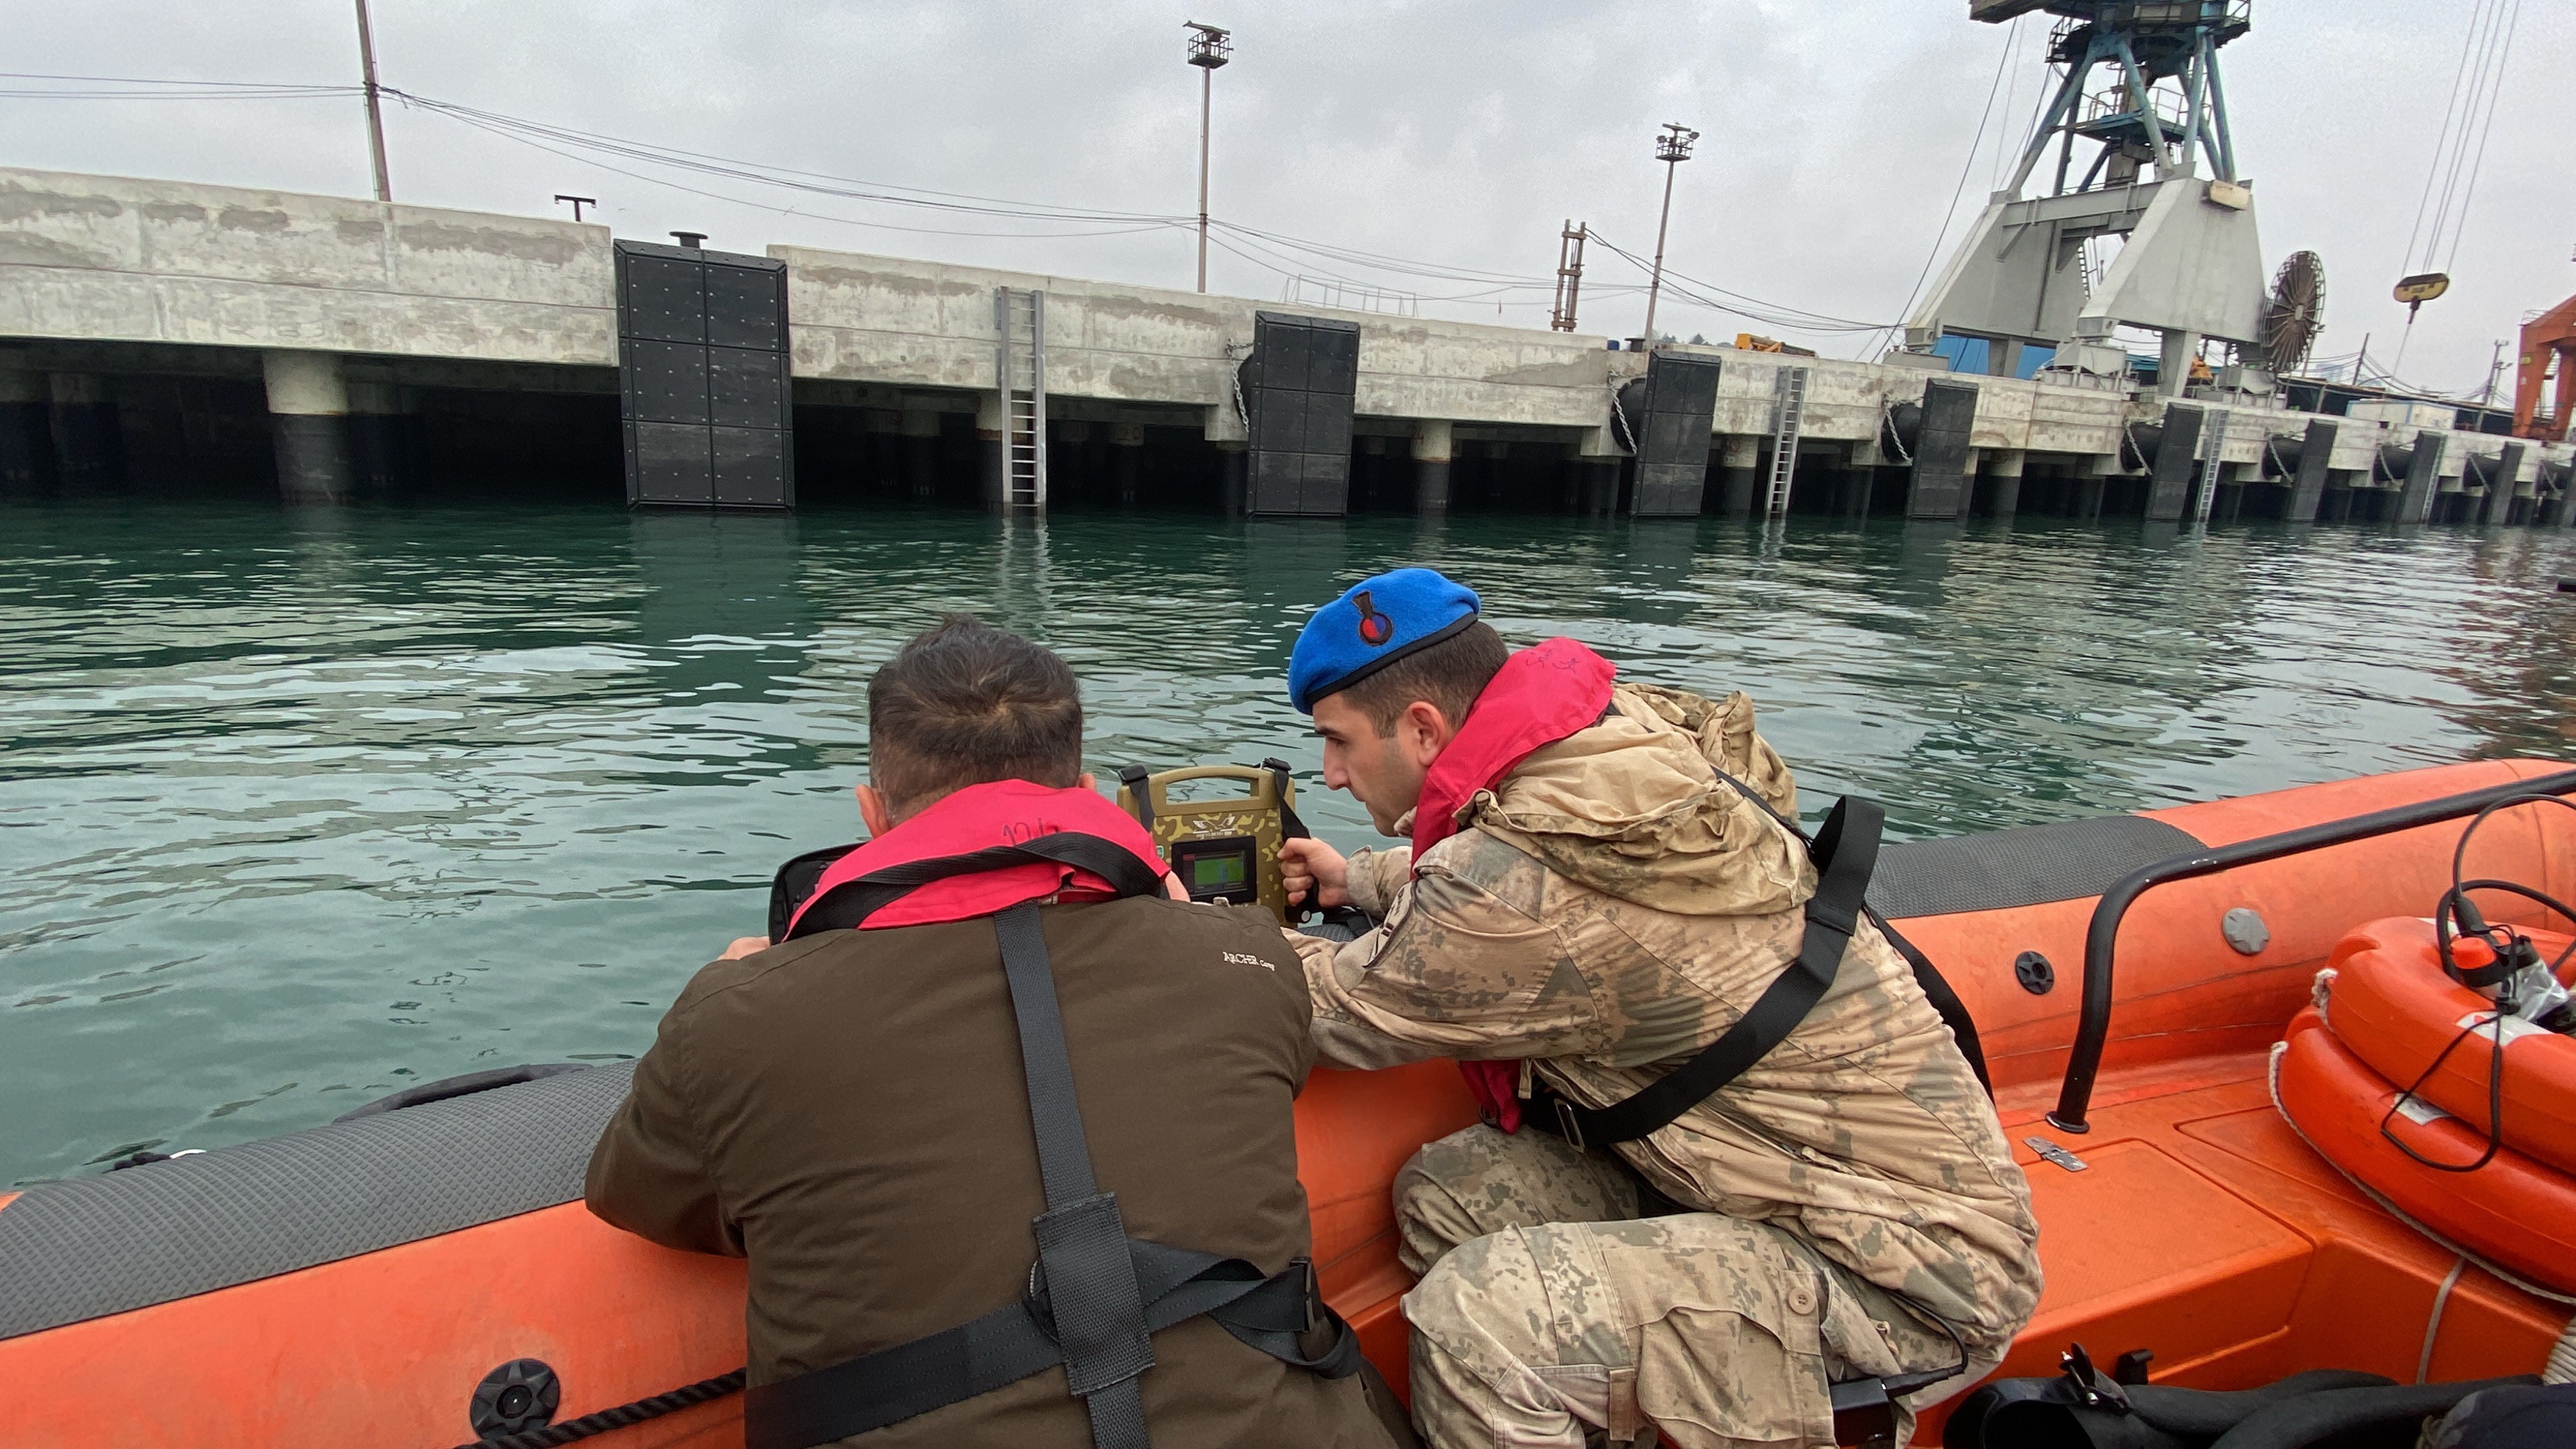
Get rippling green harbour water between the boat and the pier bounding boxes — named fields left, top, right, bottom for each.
left=0, top=506, right=2576, bottom=1181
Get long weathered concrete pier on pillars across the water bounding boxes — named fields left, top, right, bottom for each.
left=0, top=168, right=2576, bottom=526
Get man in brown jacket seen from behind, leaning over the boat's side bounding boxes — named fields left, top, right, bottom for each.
left=588, top=619, right=1401, bottom=1449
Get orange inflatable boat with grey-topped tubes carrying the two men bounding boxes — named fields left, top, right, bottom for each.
left=0, top=760, right=2576, bottom=1449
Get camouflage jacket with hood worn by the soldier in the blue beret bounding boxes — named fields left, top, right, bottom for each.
left=1296, top=684, right=2040, bottom=1356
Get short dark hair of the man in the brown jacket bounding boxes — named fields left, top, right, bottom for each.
left=868, top=614, right=1082, bottom=815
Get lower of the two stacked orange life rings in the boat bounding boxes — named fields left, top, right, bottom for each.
left=2274, top=1008, right=2576, bottom=1292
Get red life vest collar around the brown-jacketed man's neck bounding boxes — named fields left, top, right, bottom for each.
left=781, top=779, right=1169, bottom=938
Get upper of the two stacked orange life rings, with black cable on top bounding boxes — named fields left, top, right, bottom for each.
left=2326, top=918, right=2576, bottom=1173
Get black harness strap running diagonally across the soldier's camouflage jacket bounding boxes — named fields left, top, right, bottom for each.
left=1530, top=797, right=1886, bottom=1147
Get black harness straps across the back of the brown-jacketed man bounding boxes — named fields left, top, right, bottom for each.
left=742, top=833, right=1360, bottom=1449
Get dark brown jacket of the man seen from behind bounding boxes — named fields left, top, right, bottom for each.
left=588, top=900, right=1386, bottom=1449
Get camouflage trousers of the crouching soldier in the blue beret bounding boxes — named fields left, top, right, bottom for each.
left=1396, top=1127, right=1991, bottom=1449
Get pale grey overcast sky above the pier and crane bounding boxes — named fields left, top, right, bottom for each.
left=0, top=0, right=2576, bottom=394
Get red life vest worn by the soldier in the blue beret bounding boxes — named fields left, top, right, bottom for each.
left=1414, top=640, right=1618, bottom=1132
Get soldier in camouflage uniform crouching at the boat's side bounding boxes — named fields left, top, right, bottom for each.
left=1285, top=570, right=2040, bottom=1449
